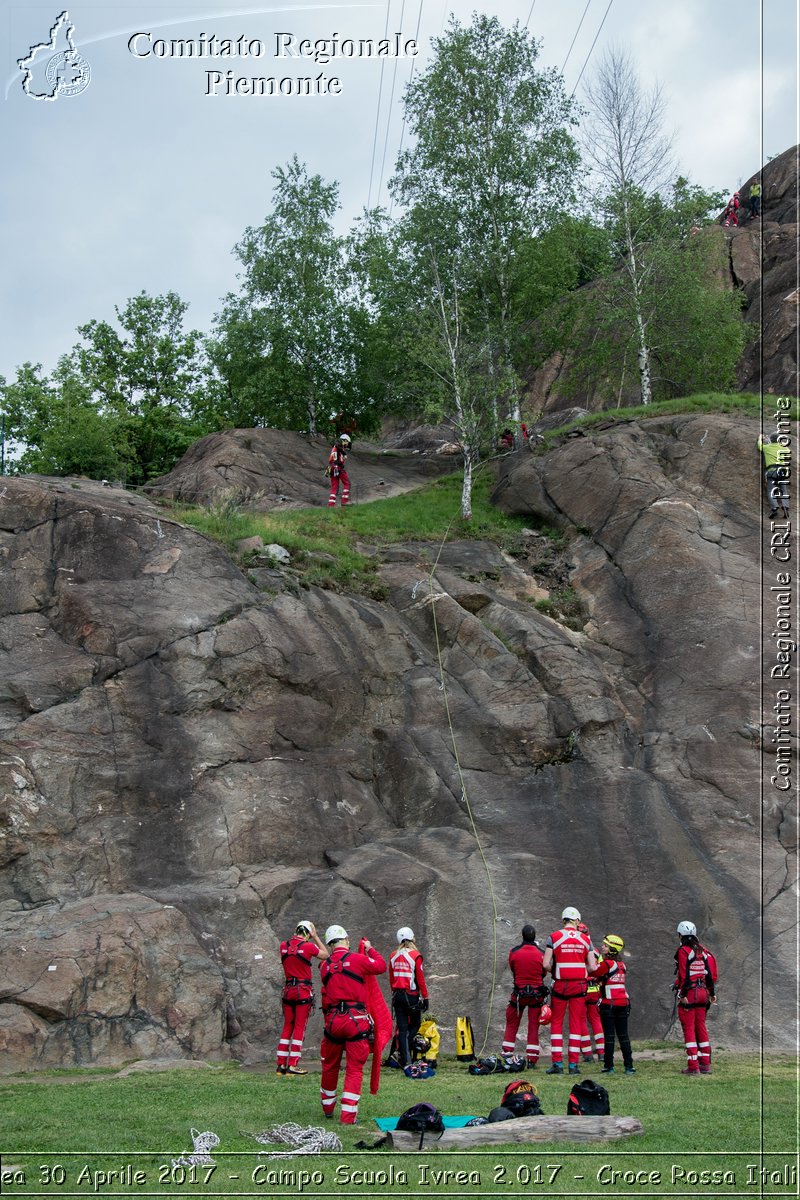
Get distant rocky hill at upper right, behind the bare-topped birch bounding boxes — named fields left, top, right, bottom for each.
left=527, top=146, right=800, bottom=415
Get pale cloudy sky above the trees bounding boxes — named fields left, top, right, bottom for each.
left=0, top=0, right=799, bottom=378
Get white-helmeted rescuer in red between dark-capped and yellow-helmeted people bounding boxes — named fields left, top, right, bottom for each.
left=542, top=907, right=597, bottom=1075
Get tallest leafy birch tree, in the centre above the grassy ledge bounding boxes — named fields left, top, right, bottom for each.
left=383, top=14, right=578, bottom=517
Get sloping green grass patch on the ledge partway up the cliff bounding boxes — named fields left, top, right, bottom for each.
left=170, top=472, right=525, bottom=600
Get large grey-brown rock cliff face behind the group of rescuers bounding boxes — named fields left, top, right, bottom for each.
left=0, top=418, right=795, bottom=1070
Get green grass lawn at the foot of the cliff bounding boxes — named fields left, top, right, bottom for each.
left=0, top=1045, right=796, bottom=1196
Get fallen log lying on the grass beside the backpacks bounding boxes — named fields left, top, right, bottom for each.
left=386, top=1116, right=644, bottom=1151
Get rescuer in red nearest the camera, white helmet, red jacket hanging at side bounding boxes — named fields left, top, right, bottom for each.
left=319, top=925, right=386, bottom=1124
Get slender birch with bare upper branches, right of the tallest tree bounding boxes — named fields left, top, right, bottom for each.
left=573, top=50, right=746, bottom=404
